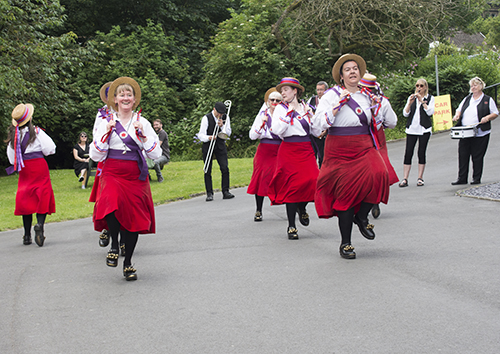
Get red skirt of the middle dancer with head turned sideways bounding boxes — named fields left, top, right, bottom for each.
left=268, top=141, right=319, bottom=205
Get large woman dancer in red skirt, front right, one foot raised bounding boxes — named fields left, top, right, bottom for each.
left=314, top=54, right=389, bottom=258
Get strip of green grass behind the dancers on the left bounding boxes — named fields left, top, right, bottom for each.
left=0, top=158, right=253, bottom=231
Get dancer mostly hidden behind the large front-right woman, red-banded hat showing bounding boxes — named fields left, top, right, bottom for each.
left=359, top=73, right=399, bottom=219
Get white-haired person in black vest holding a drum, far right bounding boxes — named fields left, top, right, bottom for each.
left=451, top=77, right=498, bottom=185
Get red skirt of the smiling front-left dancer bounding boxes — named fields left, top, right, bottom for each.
left=93, top=159, right=156, bottom=234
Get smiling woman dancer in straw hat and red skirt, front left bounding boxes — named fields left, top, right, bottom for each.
left=90, top=77, right=161, bottom=280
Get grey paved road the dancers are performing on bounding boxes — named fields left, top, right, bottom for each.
left=0, top=120, right=500, bottom=354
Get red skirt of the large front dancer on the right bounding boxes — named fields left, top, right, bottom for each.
left=315, top=135, right=389, bottom=218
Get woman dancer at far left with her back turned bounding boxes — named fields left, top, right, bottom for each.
left=7, top=103, right=56, bottom=247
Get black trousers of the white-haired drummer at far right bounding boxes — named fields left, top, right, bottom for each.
left=458, top=134, right=490, bottom=182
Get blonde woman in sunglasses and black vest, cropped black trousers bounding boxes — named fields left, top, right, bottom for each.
left=399, top=79, right=434, bottom=187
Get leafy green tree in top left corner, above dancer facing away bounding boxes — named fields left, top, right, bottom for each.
left=0, top=0, right=95, bottom=170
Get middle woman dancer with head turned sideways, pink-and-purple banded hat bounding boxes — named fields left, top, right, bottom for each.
left=268, top=77, right=321, bottom=240
